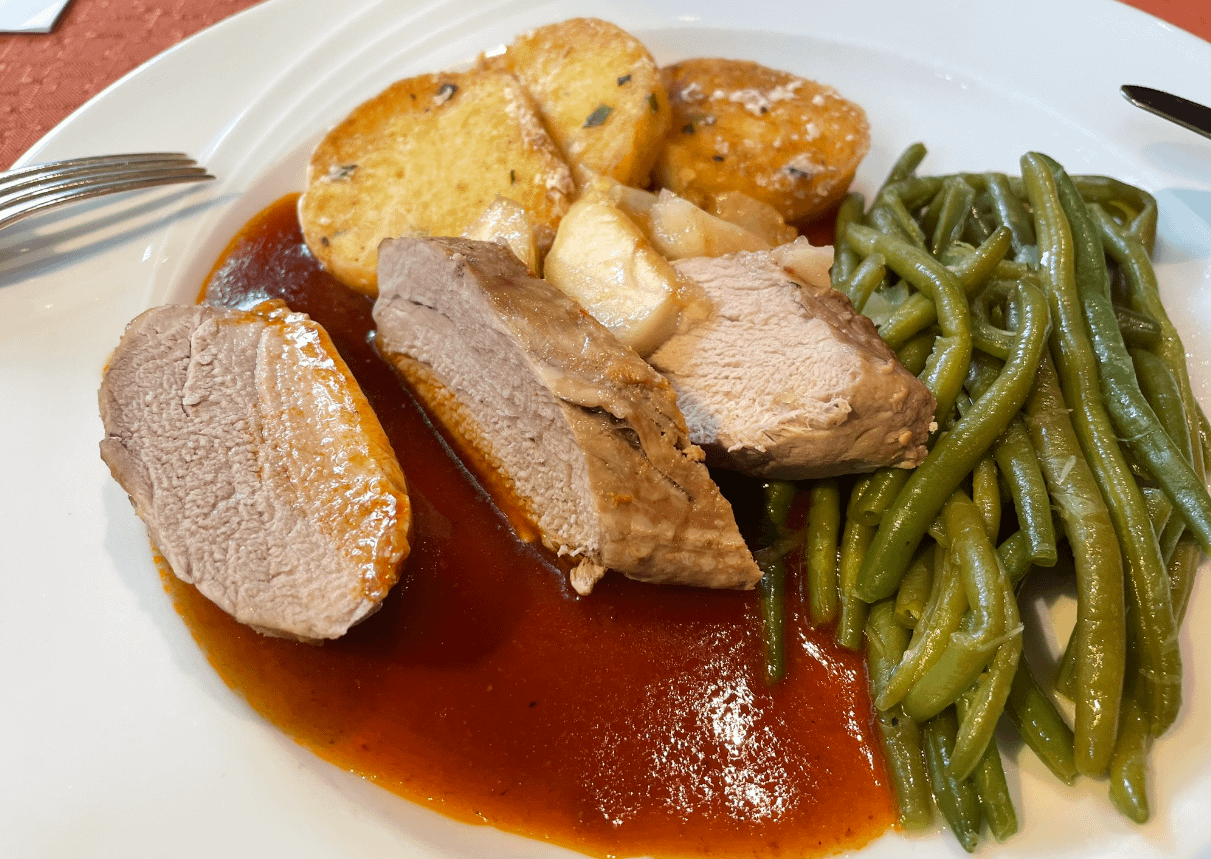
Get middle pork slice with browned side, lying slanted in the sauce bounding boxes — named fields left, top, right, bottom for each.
left=374, top=239, right=761, bottom=594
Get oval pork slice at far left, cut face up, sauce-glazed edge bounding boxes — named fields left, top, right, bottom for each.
left=99, top=302, right=411, bottom=640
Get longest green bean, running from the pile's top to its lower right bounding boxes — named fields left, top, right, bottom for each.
left=1022, top=154, right=1181, bottom=727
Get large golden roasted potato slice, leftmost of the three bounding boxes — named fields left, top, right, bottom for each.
left=299, top=69, right=575, bottom=296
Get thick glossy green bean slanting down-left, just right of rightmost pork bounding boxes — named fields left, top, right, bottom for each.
left=857, top=281, right=1050, bottom=601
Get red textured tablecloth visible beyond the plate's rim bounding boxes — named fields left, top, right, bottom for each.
left=0, top=0, right=1211, bottom=170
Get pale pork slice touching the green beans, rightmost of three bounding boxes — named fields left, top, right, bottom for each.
left=648, top=240, right=934, bottom=480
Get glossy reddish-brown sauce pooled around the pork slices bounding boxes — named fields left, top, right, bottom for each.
left=165, top=197, right=894, bottom=857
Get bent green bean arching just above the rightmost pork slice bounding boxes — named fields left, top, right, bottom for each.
left=845, top=224, right=971, bottom=423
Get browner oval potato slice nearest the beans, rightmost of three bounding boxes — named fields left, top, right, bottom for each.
left=653, top=59, right=869, bottom=222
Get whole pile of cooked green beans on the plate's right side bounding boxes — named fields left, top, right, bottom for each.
left=758, top=144, right=1211, bottom=851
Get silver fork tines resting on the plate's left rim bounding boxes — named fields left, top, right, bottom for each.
left=0, top=153, right=214, bottom=229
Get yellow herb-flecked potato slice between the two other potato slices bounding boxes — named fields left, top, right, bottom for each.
left=484, top=18, right=671, bottom=187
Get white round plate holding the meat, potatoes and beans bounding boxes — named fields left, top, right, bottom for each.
left=0, top=0, right=1211, bottom=859
